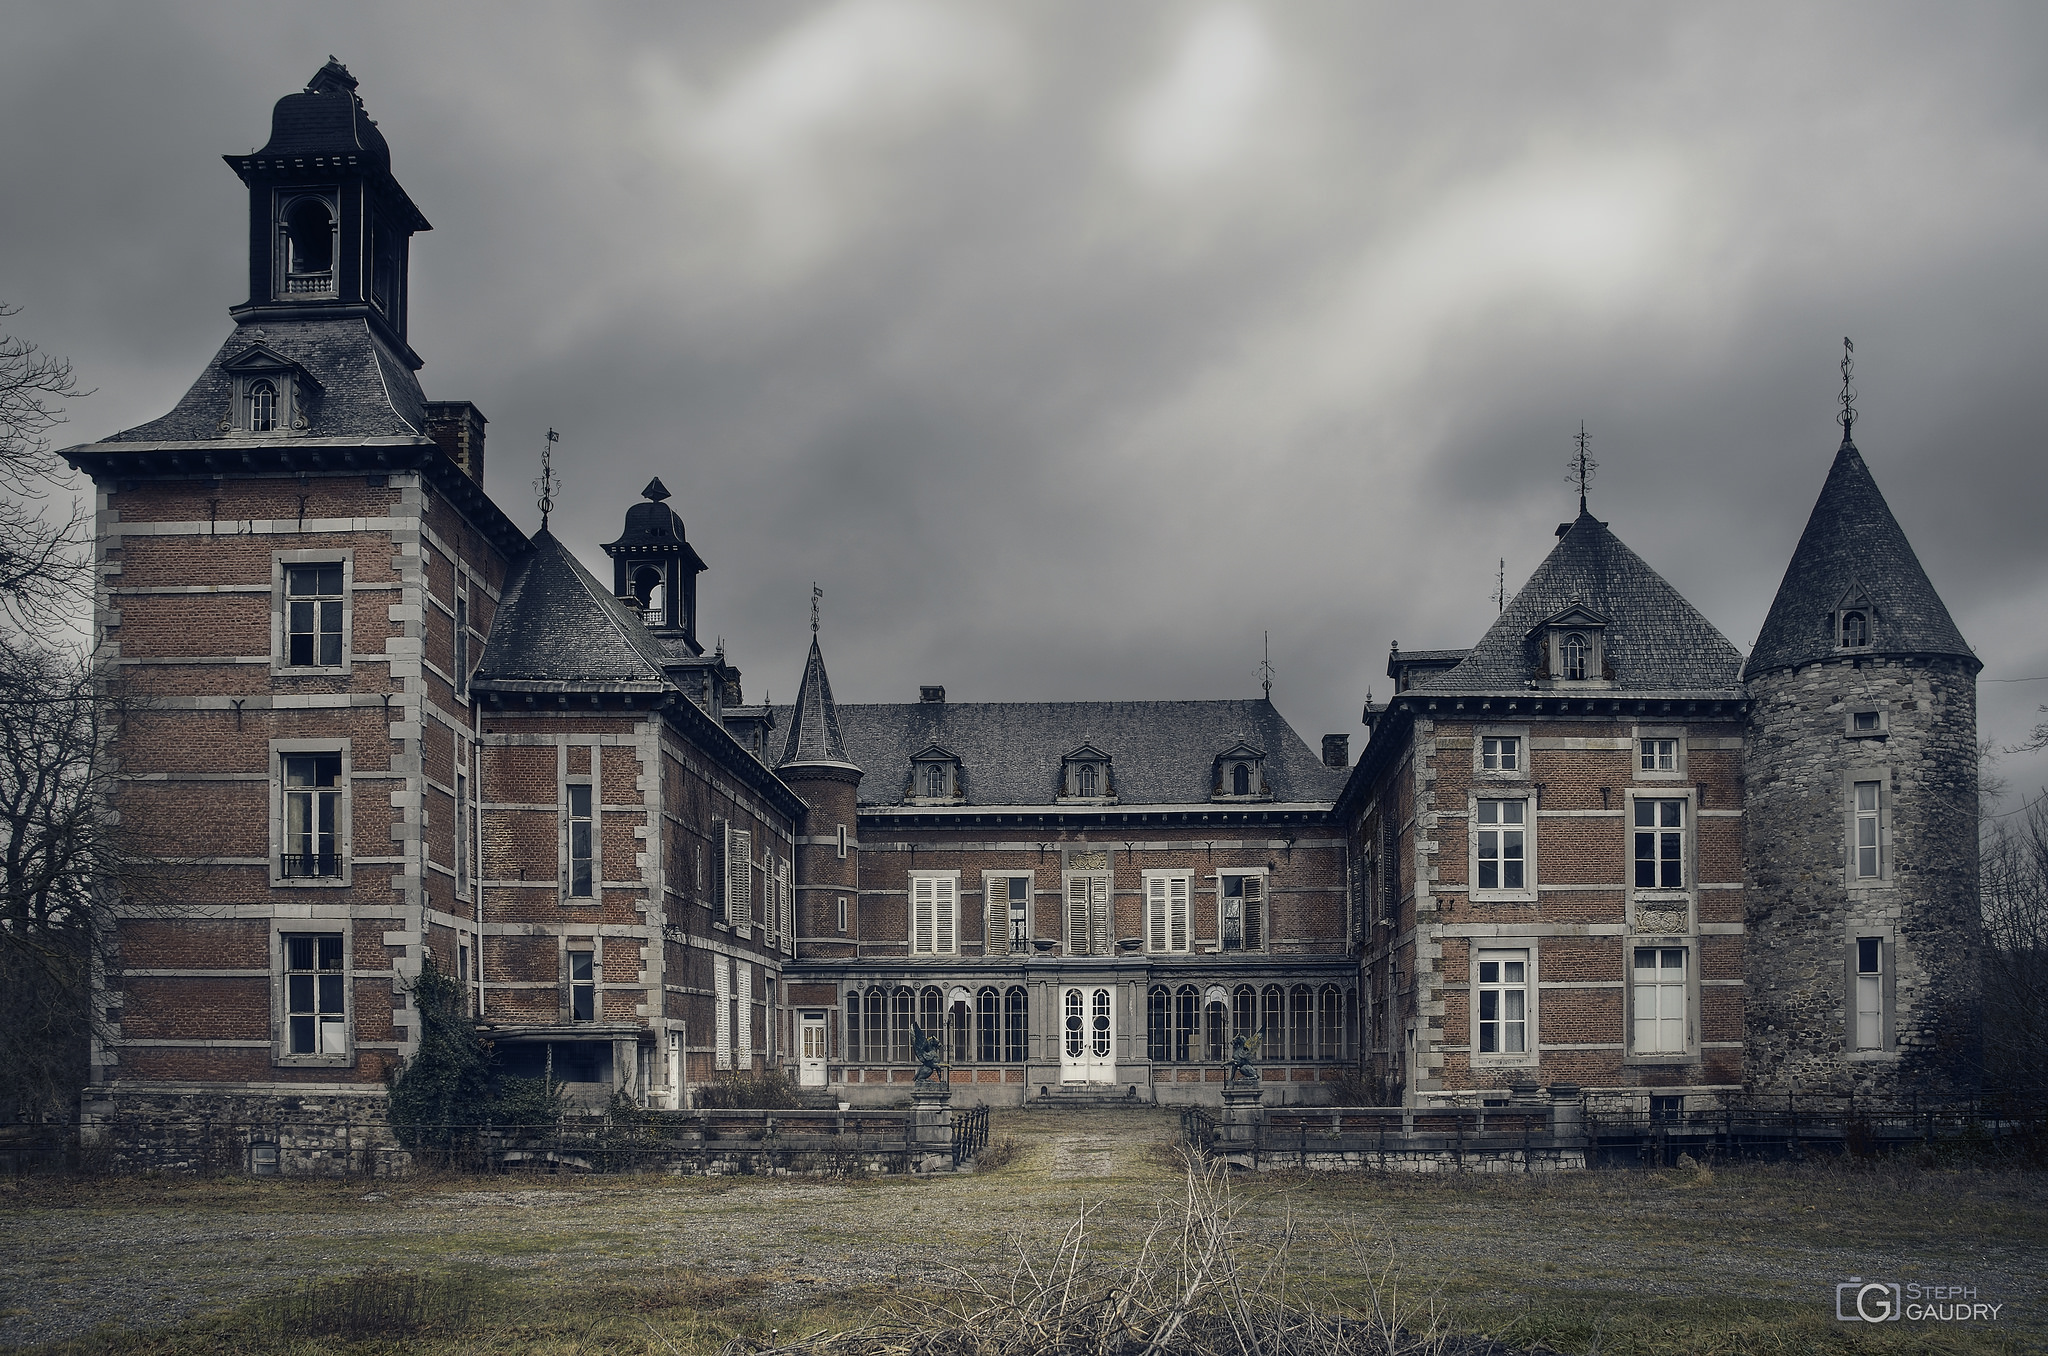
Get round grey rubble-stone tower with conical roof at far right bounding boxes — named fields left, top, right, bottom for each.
left=1743, top=422, right=1982, bottom=1100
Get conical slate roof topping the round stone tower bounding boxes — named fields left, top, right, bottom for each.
left=1743, top=436, right=1976, bottom=678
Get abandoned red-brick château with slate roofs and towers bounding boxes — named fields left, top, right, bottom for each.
left=68, top=61, right=1978, bottom=1116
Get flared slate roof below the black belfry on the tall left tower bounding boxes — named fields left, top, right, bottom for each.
left=106, top=317, right=426, bottom=444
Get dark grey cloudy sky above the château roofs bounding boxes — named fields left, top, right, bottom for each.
left=0, top=0, right=2048, bottom=793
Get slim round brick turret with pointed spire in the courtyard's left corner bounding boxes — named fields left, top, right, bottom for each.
left=776, top=633, right=860, bottom=957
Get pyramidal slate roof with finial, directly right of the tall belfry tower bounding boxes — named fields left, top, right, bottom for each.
left=471, top=528, right=668, bottom=692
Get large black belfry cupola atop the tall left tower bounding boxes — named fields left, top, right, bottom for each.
left=223, top=57, right=432, bottom=371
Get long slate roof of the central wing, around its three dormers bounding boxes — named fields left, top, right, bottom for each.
left=778, top=698, right=1346, bottom=805
